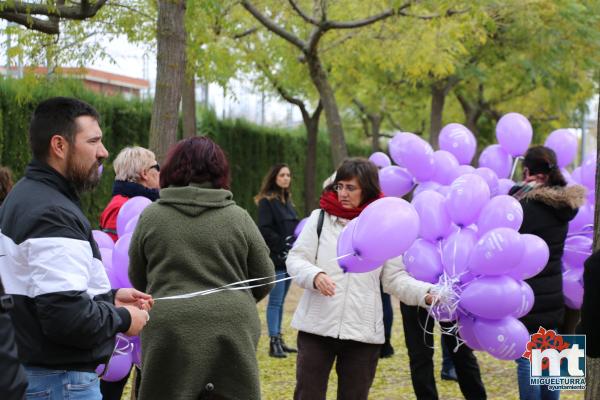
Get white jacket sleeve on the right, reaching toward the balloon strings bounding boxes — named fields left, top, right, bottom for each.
left=381, top=257, right=433, bottom=306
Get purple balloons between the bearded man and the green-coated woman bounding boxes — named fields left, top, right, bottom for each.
left=92, top=196, right=151, bottom=376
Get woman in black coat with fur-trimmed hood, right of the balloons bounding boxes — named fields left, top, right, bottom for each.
left=511, top=146, right=585, bottom=400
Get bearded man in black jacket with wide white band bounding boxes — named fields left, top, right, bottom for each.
left=0, top=97, right=152, bottom=399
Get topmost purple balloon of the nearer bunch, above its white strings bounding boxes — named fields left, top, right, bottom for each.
left=446, top=174, right=490, bottom=226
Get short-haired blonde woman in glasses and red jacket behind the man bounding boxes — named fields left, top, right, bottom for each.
left=100, top=147, right=160, bottom=400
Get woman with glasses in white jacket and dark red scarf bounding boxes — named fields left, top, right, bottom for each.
left=287, top=158, right=432, bottom=400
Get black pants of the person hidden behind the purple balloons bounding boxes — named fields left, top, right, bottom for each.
left=400, top=303, right=487, bottom=400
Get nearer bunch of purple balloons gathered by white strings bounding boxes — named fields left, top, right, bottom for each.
left=404, top=171, right=549, bottom=360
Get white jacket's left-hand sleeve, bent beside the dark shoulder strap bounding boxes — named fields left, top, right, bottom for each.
left=285, top=210, right=325, bottom=290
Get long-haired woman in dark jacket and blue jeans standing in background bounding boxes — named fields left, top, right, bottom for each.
left=254, top=164, right=298, bottom=358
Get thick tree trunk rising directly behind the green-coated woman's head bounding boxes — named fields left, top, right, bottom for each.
left=150, top=0, right=185, bottom=161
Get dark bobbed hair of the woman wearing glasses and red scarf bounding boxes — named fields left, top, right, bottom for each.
left=325, top=157, right=381, bottom=205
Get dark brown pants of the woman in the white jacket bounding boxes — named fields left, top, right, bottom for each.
left=294, top=331, right=381, bottom=400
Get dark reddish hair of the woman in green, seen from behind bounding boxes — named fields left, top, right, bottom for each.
left=160, top=136, right=230, bottom=189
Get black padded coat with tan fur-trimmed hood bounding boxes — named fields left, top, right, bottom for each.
left=519, top=185, right=585, bottom=333
